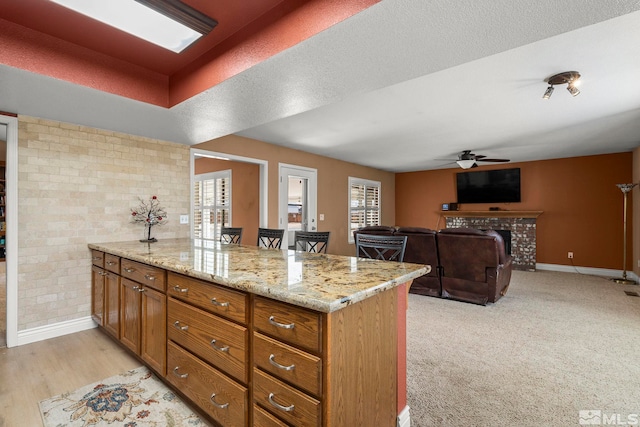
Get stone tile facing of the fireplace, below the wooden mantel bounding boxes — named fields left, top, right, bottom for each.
left=446, top=217, right=536, bottom=271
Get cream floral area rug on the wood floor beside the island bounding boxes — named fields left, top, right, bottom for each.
left=39, top=367, right=209, bottom=427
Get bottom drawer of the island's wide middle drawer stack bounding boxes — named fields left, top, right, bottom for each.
left=167, top=342, right=248, bottom=427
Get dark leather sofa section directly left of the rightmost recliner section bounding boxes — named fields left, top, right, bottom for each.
left=394, top=227, right=442, bottom=297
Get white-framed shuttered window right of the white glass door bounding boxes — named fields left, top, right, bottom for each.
left=349, top=177, right=380, bottom=243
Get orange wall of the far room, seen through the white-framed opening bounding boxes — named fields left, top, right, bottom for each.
left=194, top=157, right=260, bottom=244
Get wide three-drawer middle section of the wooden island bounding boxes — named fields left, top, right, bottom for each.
left=167, top=272, right=250, bottom=426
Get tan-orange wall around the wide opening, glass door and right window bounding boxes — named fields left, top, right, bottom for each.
left=193, top=135, right=396, bottom=255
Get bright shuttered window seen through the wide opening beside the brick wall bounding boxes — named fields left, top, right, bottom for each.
left=193, top=170, right=231, bottom=247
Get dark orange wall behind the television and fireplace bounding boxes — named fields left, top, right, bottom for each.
left=396, top=150, right=639, bottom=270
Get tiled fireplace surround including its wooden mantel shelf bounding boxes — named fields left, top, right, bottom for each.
left=443, top=211, right=542, bottom=271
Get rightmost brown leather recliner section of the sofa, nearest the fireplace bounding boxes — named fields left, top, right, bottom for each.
left=438, top=228, right=512, bottom=305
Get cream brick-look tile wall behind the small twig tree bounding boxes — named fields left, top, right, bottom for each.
left=18, top=116, right=191, bottom=330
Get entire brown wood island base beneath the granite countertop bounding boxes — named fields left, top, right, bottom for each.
left=92, top=251, right=398, bottom=427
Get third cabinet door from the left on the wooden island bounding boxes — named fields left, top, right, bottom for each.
left=120, top=278, right=142, bottom=354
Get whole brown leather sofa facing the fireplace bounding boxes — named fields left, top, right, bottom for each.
left=354, top=226, right=512, bottom=305
